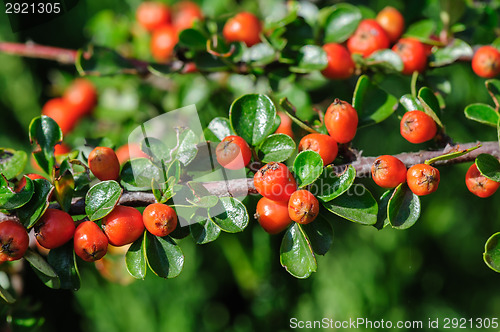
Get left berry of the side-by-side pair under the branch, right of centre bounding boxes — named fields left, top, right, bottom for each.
left=372, top=155, right=406, bottom=188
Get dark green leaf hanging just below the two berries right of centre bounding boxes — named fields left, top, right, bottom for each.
left=387, top=183, right=420, bottom=229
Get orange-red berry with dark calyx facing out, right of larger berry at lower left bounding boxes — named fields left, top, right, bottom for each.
left=142, top=203, right=177, bottom=237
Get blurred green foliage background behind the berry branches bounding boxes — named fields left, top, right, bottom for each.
left=0, top=0, right=500, bottom=332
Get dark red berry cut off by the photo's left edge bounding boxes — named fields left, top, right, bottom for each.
left=0, top=220, right=29, bottom=263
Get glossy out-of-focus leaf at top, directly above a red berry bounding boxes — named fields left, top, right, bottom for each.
left=325, top=3, right=361, bottom=43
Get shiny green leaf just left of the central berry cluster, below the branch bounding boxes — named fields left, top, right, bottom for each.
left=208, top=197, right=249, bottom=233
